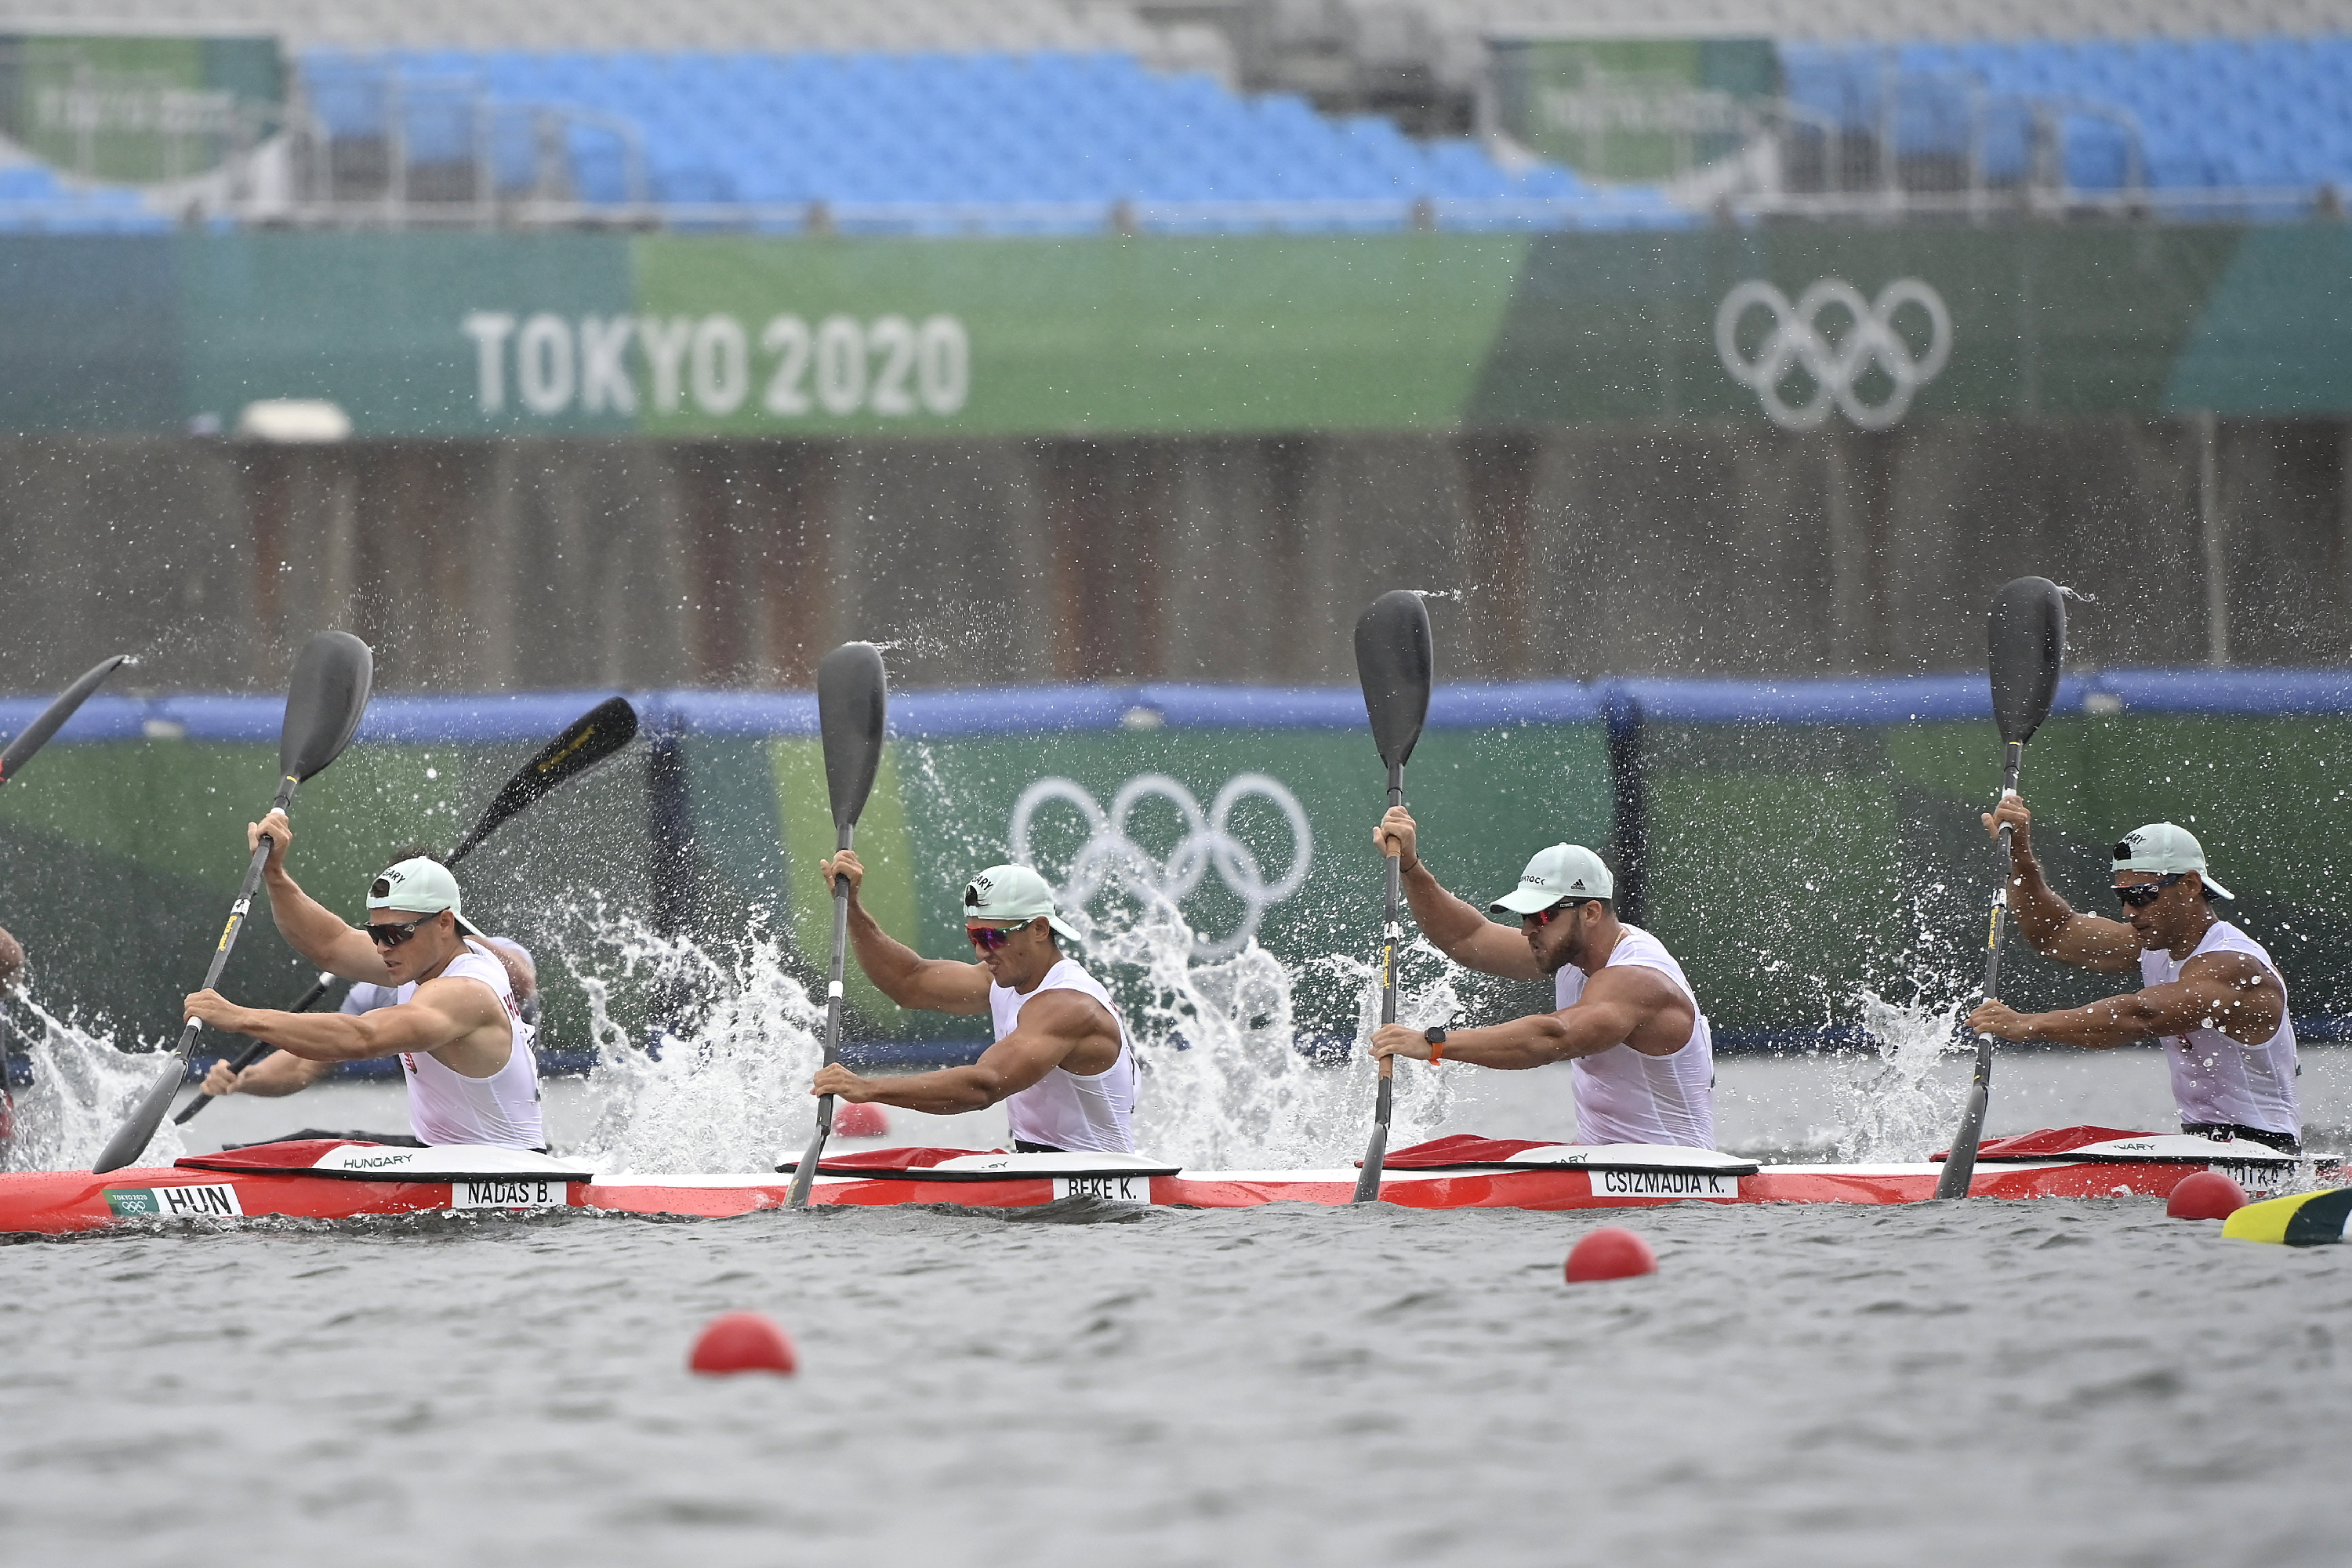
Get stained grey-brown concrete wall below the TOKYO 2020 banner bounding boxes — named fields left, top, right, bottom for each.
left=0, top=419, right=2352, bottom=691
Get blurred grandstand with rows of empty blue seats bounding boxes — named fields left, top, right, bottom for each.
left=0, top=0, right=2352, bottom=235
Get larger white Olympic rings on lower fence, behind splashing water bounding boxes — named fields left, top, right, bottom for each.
left=1007, top=774, right=1315, bottom=959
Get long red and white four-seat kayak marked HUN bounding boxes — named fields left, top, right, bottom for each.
left=0, top=1128, right=2333, bottom=1234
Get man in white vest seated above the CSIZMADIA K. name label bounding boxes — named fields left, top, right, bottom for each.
left=1371, top=806, right=1715, bottom=1149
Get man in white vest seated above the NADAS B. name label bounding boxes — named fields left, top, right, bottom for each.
left=186, top=811, right=546, bottom=1149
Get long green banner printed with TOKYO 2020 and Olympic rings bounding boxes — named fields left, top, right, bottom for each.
left=0, top=223, right=2352, bottom=437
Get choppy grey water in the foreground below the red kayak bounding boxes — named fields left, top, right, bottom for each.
left=0, top=1201, right=2352, bottom=1568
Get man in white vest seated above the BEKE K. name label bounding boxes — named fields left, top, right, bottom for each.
left=809, top=848, right=1136, bottom=1154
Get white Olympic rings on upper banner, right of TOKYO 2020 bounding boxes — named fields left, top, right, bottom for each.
left=1715, top=278, right=1952, bottom=430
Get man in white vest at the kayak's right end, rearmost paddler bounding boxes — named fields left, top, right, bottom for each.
left=1969, top=794, right=2303, bottom=1154
